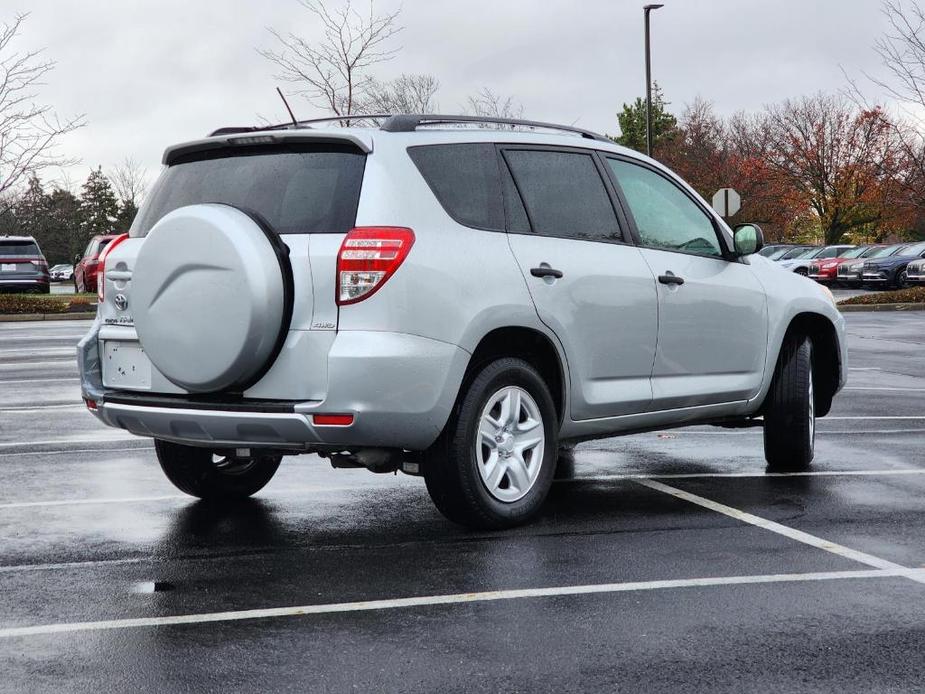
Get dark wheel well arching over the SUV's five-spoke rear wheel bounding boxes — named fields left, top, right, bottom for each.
left=465, top=327, right=565, bottom=422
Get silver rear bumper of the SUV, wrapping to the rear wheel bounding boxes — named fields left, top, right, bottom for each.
left=78, top=323, right=469, bottom=451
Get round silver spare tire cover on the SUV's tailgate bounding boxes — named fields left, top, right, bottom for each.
left=131, top=204, right=286, bottom=393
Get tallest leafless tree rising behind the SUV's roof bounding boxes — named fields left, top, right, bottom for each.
left=259, top=0, right=402, bottom=116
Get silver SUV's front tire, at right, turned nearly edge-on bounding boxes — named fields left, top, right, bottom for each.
left=764, top=335, right=816, bottom=472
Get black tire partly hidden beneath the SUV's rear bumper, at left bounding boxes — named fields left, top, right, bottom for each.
left=154, top=439, right=282, bottom=501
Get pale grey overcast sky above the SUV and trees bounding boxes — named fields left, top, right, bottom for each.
left=10, top=0, right=900, bottom=186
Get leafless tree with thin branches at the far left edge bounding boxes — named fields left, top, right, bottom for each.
left=0, top=14, right=85, bottom=196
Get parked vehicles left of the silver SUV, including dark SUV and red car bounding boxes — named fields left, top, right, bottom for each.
left=0, top=235, right=122, bottom=294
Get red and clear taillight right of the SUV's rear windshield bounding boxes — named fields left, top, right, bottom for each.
left=337, top=227, right=414, bottom=306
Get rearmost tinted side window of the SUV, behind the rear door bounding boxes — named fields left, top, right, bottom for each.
left=408, top=143, right=504, bottom=231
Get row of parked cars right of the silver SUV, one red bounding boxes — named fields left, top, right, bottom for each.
left=761, top=241, right=925, bottom=289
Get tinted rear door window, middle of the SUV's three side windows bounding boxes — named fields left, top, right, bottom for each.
left=504, top=149, right=623, bottom=241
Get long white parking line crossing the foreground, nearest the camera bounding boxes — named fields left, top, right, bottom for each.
left=0, top=569, right=908, bottom=638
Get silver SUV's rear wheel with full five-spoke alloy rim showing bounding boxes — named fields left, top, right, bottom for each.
left=423, top=357, right=558, bottom=530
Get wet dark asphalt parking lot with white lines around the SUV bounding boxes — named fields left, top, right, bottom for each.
left=0, top=313, right=925, bottom=692
